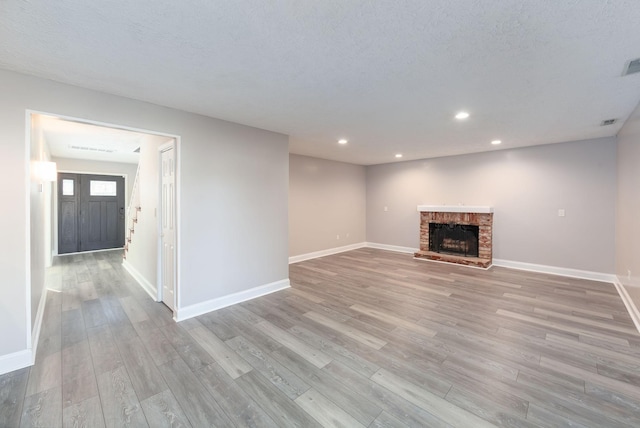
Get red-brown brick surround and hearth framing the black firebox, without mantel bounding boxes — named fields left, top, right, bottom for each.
left=414, top=211, right=493, bottom=268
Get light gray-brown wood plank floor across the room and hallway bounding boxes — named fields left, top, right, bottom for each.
left=0, top=249, right=640, bottom=427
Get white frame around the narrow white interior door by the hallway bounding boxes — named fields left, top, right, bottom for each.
left=156, top=137, right=180, bottom=314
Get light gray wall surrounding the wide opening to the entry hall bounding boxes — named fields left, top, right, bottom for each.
left=0, top=70, right=289, bottom=366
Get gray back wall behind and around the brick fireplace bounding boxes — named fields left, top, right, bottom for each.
left=367, top=138, right=616, bottom=273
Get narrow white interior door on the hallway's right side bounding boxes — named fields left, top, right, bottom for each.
left=160, top=145, right=176, bottom=310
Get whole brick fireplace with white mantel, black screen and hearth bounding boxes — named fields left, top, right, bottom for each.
left=414, top=205, right=493, bottom=268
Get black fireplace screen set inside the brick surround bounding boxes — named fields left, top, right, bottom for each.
left=429, top=223, right=480, bottom=257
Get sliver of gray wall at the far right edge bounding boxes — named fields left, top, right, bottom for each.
left=616, top=101, right=640, bottom=307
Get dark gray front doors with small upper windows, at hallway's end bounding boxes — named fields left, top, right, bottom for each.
left=58, top=173, right=125, bottom=254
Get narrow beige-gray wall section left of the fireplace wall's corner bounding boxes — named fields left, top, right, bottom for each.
left=289, top=155, right=366, bottom=256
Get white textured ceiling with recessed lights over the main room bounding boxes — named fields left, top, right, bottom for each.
left=0, top=0, right=640, bottom=164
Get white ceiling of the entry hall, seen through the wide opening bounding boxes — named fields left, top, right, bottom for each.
left=37, top=115, right=146, bottom=163
